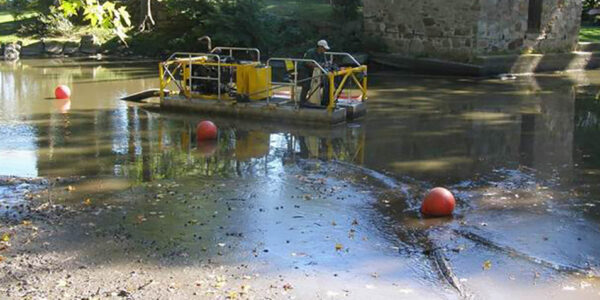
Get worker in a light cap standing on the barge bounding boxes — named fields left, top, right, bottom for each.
left=300, top=40, right=331, bottom=106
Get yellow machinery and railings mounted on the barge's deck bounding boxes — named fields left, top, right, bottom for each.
left=159, top=42, right=367, bottom=122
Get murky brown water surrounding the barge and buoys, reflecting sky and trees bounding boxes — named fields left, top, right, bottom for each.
left=0, top=60, right=600, bottom=298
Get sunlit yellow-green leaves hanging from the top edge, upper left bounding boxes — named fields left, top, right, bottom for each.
left=59, top=0, right=131, bottom=42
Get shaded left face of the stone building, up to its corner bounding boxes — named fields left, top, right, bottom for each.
left=364, top=0, right=480, bottom=58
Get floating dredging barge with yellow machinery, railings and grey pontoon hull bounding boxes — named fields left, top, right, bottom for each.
left=152, top=39, right=367, bottom=125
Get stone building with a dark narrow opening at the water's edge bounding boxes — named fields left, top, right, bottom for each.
left=364, top=0, right=582, bottom=61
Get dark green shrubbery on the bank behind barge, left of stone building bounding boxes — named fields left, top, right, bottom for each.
left=130, top=0, right=364, bottom=57
